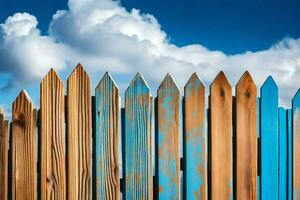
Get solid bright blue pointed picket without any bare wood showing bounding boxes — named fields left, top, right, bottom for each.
left=260, top=76, right=279, bottom=200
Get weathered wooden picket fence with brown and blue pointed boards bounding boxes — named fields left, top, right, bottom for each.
left=0, top=64, right=300, bottom=200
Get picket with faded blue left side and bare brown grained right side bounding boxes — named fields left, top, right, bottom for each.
left=95, top=73, right=120, bottom=200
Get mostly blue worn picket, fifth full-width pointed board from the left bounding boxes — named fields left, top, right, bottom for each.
left=123, top=73, right=152, bottom=200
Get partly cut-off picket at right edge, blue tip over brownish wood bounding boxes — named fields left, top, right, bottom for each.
left=292, top=89, right=300, bottom=200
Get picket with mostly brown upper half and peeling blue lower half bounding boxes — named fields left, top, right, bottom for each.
left=183, top=73, right=207, bottom=200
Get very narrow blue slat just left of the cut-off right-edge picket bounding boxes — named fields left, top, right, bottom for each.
left=287, top=109, right=293, bottom=200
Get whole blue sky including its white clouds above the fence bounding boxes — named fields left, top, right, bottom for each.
left=0, top=0, right=300, bottom=117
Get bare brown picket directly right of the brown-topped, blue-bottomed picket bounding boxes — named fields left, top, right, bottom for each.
left=210, top=72, right=233, bottom=200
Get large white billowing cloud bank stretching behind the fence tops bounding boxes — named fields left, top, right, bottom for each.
left=0, top=0, right=300, bottom=104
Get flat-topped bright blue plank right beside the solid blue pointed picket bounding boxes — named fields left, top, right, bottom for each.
left=279, top=108, right=287, bottom=200
